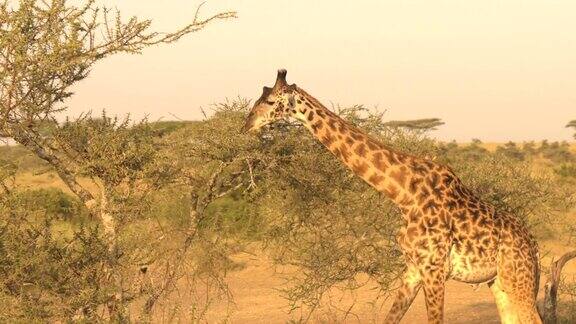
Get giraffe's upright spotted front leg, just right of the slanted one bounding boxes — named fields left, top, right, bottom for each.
left=423, top=268, right=446, bottom=324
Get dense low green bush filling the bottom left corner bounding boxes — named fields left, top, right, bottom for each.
left=0, top=197, right=109, bottom=322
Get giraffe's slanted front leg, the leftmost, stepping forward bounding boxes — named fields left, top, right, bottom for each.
left=384, top=265, right=422, bottom=323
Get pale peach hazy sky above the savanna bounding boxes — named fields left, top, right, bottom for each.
left=68, top=0, right=576, bottom=142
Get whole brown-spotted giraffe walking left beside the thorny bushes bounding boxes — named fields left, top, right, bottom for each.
left=243, top=70, right=541, bottom=323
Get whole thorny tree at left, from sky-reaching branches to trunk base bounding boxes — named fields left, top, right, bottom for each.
left=0, top=0, right=236, bottom=318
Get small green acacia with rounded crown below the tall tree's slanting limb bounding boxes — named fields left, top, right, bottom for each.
left=53, top=113, right=178, bottom=318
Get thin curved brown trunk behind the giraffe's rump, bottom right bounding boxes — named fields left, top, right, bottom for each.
left=543, top=250, right=576, bottom=324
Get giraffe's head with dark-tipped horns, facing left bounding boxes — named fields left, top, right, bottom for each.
left=242, top=70, right=297, bottom=132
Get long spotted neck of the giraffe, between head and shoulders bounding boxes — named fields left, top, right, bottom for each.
left=296, top=88, right=422, bottom=206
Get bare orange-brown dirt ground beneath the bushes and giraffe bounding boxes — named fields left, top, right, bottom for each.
left=207, top=242, right=576, bottom=324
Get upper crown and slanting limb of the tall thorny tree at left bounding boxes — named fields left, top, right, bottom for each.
left=0, top=0, right=235, bottom=204
